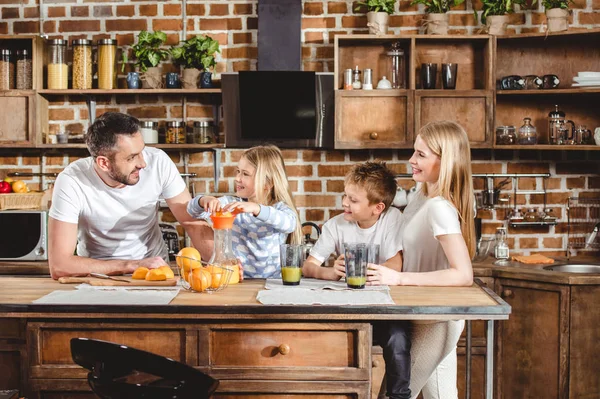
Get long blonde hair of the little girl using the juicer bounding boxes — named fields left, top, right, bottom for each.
left=242, top=145, right=302, bottom=244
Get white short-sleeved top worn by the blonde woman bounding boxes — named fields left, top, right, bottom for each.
left=402, top=191, right=462, bottom=272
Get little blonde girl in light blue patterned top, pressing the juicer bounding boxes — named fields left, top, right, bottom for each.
left=187, top=146, right=302, bottom=278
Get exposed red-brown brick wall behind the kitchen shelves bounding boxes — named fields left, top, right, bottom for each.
left=0, top=0, right=600, bottom=254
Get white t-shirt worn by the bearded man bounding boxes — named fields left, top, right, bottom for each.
left=49, top=147, right=186, bottom=260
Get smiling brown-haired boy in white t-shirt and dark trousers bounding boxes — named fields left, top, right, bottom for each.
left=302, top=162, right=410, bottom=399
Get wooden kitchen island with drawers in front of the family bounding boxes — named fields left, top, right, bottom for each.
left=0, top=277, right=510, bottom=399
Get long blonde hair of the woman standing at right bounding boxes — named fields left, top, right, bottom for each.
left=419, top=121, right=475, bottom=258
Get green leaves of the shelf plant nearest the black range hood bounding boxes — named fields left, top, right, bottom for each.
left=170, top=35, right=221, bottom=71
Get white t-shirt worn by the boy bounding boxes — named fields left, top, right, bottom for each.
left=310, top=207, right=402, bottom=264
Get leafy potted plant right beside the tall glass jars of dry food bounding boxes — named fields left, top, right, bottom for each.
left=123, top=30, right=169, bottom=89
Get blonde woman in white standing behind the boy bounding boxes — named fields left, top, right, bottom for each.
left=368, top=121, right=475, bottom=399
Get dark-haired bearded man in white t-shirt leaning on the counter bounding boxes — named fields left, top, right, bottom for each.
left=48, top=112, right=213, bottom=279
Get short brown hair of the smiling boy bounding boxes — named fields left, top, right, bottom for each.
left=344, top=161, right=398, bottom=211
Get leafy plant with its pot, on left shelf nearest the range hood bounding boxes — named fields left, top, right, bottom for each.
left=170, top=35, right=221, bottom=89
